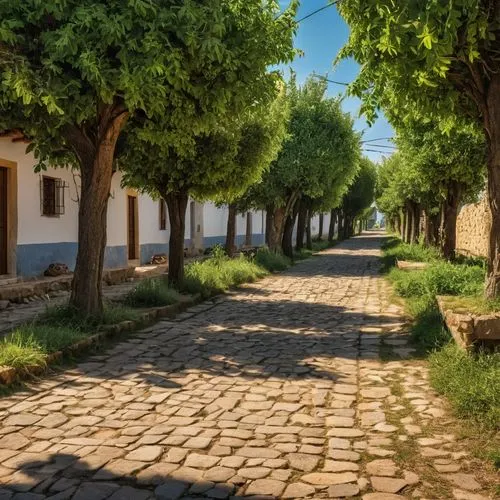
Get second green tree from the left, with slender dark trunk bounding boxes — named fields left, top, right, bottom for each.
left=120, top=82, right=287, bottom=285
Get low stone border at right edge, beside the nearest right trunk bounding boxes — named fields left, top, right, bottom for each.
left=436, top=295, right=500, bottom=350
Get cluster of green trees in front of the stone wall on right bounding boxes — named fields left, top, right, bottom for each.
left=377, top=118, right=486, bottom=259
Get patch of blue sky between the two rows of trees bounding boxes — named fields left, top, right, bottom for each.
left=280, top=0, right=394, bottom=161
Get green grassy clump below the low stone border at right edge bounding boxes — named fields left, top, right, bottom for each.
left=429, top=343, right=500, bottom=428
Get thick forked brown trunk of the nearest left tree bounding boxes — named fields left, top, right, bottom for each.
left=69, top=105, right=128, bottom=316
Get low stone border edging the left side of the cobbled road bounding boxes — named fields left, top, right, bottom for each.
left=0, top=295, right=202, bottom=386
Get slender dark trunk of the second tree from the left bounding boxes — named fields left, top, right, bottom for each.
left=163, top=192, right=188, bottom=287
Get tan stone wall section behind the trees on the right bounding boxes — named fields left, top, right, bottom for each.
left=457, top=197, right=491, bottom=257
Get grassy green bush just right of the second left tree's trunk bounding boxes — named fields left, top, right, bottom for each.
left=181, top=249, right=267, bottom=297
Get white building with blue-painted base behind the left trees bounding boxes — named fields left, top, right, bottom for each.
left=0, top=138, right=265, bottom=277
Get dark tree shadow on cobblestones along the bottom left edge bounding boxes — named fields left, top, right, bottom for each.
left=0, top=452, right=278, bottom=500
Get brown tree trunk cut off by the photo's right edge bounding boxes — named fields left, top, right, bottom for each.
left=482, top=73, right=500, bottom=298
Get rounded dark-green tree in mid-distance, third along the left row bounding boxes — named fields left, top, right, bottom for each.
left=248, top=77, right=360, bottom=256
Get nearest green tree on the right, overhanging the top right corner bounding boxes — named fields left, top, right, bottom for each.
left=338, top=0, right=500, bottom=297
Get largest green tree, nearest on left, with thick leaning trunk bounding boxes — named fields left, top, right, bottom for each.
left=0, top=0, right=296, bottom=314
